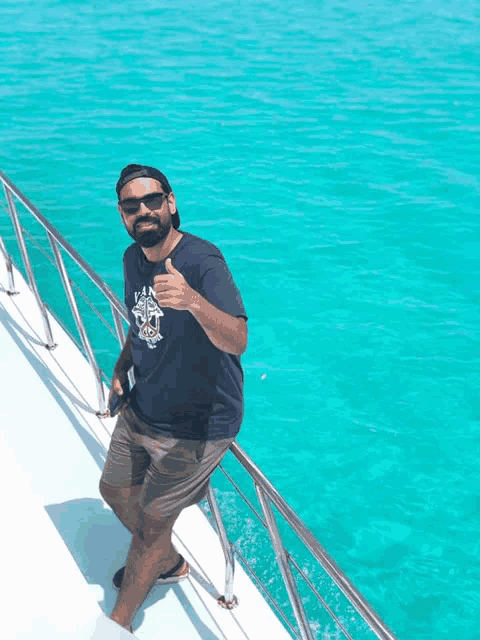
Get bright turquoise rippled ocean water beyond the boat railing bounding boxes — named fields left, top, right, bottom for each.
left=0, top=0, right=480, bottom=640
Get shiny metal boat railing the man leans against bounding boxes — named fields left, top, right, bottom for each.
left=0, top=171, right=396, bottom=640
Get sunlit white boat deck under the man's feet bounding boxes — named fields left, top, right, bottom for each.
left=0, top=255, right=291, bottom=640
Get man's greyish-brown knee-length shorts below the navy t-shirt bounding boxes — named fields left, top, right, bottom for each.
left=102, top=407, right=235, bottom=518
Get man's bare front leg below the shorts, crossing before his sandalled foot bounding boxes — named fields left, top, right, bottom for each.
left=110, top=511, right=185, bottom=630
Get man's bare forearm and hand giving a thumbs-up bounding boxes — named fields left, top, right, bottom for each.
left=153, top=258, right=247, bottom=355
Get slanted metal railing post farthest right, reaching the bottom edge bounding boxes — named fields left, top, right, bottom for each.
left=255, top=482, right=313, bottom=640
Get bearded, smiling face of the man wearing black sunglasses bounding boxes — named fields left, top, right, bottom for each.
left=118, top=178, right=175, bottom=249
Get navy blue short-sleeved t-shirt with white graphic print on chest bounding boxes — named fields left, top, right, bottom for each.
left=123, top=232, right=247, bottom=440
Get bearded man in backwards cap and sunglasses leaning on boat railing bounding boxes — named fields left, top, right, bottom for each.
left=100, top=165, right=247, bottom=631
